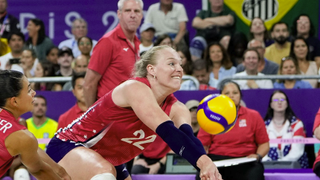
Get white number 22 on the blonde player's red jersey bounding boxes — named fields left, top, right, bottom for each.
left=121, top=129, right=157, bottom=150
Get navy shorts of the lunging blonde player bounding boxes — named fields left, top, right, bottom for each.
left=46, top=137, right=129, bottom=180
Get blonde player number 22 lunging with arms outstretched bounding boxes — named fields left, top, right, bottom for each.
left=47, top=46, right=221, bottom=180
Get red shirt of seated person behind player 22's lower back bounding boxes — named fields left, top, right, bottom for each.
left=58, top=104, right=84, bottom=129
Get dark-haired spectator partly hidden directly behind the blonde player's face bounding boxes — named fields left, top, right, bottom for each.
left=176, top=45, right=192, bottom=75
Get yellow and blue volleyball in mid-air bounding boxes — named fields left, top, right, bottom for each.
left=197, top=94, right=237, bottom=135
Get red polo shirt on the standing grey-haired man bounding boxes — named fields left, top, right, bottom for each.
left=88, top=25, right=140, bottom=99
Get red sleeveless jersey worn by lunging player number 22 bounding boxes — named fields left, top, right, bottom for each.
left=56, top=78, right=177, bottom=166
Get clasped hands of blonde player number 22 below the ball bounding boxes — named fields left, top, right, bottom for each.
left=197, top=155, right=222, bottom=180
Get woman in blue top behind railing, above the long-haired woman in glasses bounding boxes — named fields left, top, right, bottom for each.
left=273, top=57, right=312, bottom=89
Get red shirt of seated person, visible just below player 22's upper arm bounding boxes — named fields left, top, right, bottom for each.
left=142, top=136, right=171, bottom=159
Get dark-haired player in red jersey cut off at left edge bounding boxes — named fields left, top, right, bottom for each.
left=0, top=70, right=70, bottom=180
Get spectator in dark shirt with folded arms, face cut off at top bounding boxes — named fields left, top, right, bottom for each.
left=192, top=0, right=236, bottom=43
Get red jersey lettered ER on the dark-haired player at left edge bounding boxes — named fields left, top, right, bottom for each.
left=0, top=108, right=27, bottom=177
